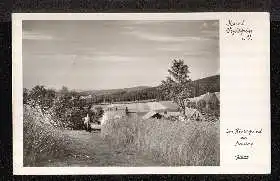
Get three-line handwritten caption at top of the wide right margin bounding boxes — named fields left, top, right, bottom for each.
left=226, top=20, right=253, bottom=40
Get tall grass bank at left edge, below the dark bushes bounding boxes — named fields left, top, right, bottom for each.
left=23, top=105, right=71, bottom=166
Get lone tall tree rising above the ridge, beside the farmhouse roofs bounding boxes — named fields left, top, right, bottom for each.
left=160, top=60, right=193, bottom=115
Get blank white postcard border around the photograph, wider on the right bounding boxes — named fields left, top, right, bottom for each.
left=12, top=12, right=270, bottom=175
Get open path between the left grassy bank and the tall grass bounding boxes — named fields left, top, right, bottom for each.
left=39, top=130, right=161, bottom=167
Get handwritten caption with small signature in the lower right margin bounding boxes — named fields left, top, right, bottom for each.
left=226, top=128, right=263, bottom=160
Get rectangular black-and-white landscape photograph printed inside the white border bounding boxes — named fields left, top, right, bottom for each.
left=22, top=20, right=220, bottom=167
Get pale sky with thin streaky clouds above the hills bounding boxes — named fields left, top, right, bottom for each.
left=22, top=20, right=220, bottom=90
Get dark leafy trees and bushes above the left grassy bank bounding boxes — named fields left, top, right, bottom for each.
left=23, top=85, right=104, bottom=130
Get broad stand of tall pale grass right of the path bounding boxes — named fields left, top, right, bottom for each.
left=101, top=115, right=220, bottom=166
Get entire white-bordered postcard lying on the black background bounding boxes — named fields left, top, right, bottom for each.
left=12, top=12, right=271, bottom=175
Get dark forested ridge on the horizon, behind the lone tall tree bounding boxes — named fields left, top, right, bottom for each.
left=77, top=75, right=220, bottom=103
